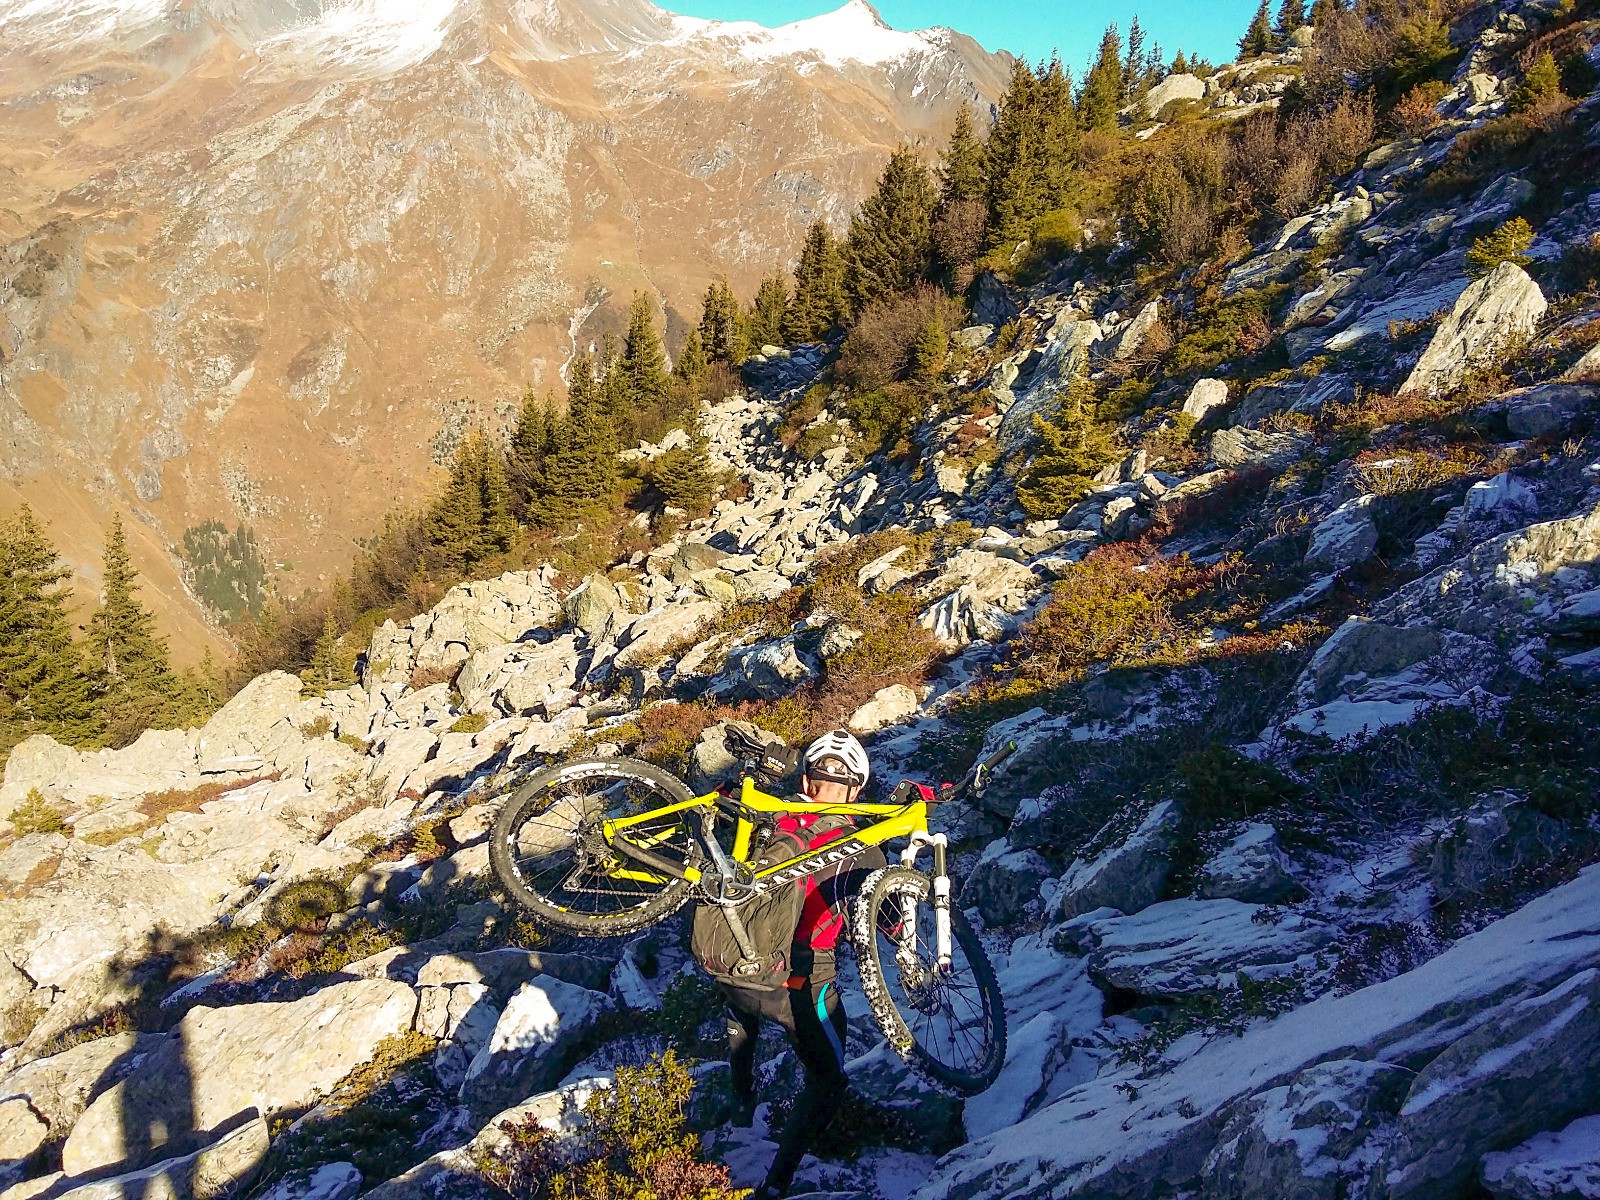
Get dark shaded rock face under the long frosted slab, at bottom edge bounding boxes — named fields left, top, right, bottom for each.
left=1200, top=1059, right=1411, bottom=1200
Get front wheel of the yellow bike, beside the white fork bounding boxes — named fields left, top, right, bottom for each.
left=851, top=867, right=1005, bottom=1096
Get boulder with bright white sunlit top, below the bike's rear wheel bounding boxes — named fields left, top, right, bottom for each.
left=461, top=976, right=611, bottom=1115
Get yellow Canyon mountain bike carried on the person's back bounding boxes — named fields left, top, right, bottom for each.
left=490, top=738, right=1014, bottom=1096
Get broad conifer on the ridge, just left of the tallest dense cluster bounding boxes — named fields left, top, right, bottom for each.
left=845, top=146, right=938, bottom=312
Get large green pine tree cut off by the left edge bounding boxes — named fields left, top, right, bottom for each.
left=0, top=504, right=93, bottom=749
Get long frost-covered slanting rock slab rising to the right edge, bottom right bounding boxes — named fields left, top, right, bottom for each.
left=915, top=867, right=1600, bottom=1200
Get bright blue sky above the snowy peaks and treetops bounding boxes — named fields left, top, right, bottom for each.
left=658, top=0, right=1277, bottom=74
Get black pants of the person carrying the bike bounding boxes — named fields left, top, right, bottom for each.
left=723, top=981, right=848, bottom=1194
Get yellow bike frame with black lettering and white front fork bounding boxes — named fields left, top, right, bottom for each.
left=602, top=776, right=952, bottom=970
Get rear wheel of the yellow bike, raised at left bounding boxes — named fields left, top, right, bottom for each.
left=490, top=758, right=698, bottom=938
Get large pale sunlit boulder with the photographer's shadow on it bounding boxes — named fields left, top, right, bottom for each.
left=61, top=981, right=416, bottom=1174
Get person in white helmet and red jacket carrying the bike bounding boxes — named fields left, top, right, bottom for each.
left=722, top=730, right=886, bottom=1200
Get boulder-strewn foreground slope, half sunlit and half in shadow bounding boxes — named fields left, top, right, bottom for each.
left=0, top=13, right=1600, bottom=1200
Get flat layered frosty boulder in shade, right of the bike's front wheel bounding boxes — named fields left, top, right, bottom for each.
left=1088, top=899, right=1338, bottom=997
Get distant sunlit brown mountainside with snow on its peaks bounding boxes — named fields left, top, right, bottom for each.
left=0, top=0, right=1006, bottom=643
